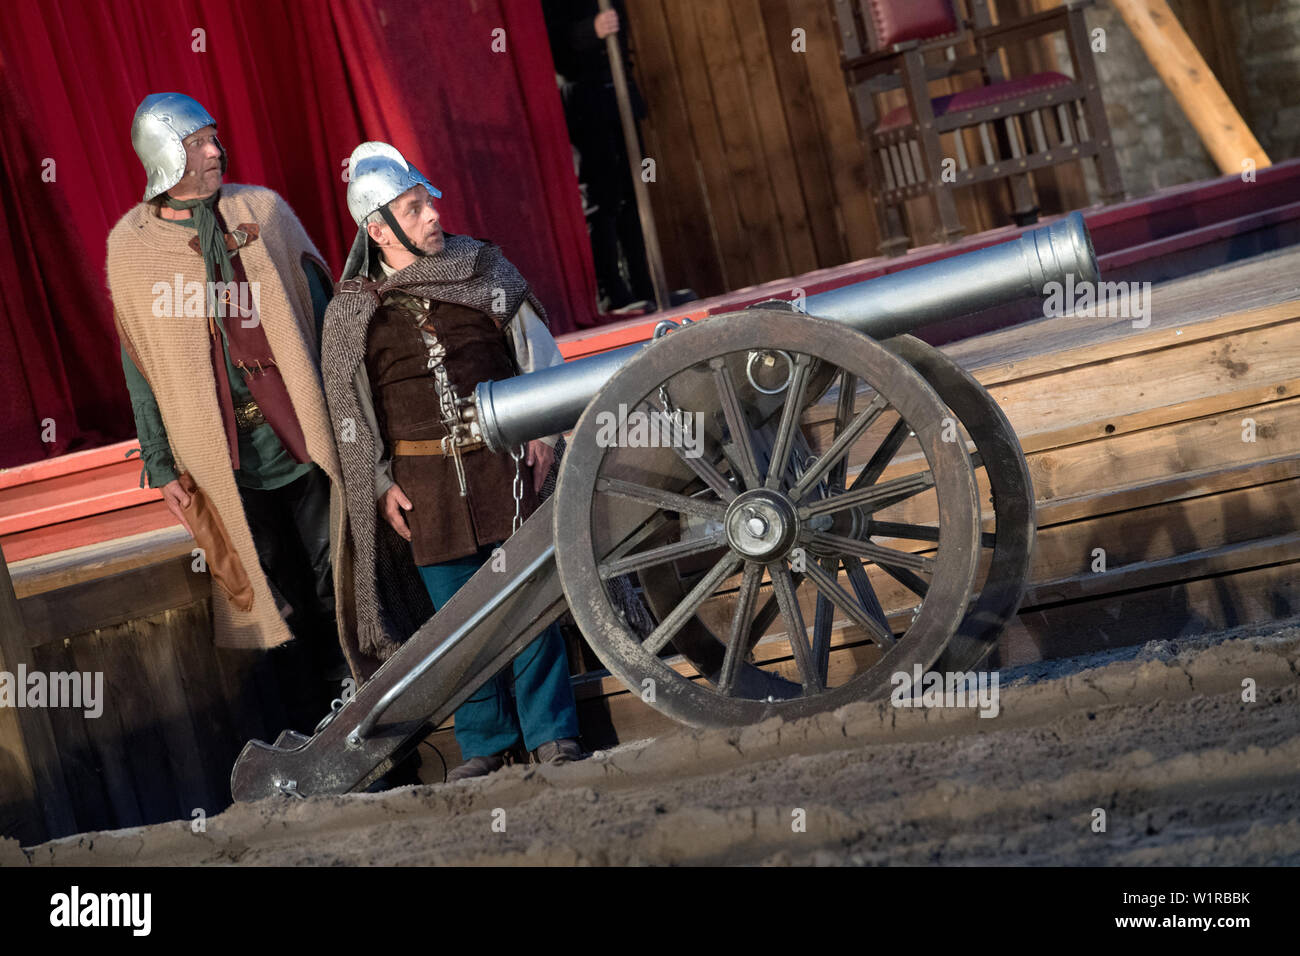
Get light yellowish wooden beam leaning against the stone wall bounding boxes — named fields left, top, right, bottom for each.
left=1114, top=0, right=1273, bottom=176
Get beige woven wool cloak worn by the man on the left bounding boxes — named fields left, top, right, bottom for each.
left=108, top=183, right=377, bottom=676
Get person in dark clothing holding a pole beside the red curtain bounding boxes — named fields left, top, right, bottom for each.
left=542, top=0, right=654, bottom=308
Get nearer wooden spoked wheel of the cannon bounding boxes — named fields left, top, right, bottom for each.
left=555, top=310, right=980, bottom=726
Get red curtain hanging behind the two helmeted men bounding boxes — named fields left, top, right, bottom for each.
left=0, top=0, right=595, bottom=467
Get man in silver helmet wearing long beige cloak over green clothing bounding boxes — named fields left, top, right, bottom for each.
left=108, top=92, right=356, bottom=731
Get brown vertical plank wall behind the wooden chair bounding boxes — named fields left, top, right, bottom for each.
left=627, top=0, right=1088, bottom=295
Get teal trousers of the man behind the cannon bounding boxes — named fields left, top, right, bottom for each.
left=419, top=545, right=579, bottom=760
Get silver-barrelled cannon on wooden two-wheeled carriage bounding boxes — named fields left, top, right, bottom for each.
left=231, top=213, right=1099, bottom=800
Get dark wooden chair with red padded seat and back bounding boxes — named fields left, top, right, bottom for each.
left=831, top=0, right=1123, bottom=255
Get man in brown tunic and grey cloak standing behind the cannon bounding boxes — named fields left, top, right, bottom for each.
left=321, top=143, right=581, bottom=780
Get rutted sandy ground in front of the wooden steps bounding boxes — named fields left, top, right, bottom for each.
left=0, top=626, right=1300, bottom=865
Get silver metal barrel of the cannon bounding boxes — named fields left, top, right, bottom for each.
left=475, top=212, right=1099, bottom=451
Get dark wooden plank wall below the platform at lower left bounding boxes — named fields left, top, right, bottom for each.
left=0, top=554, right=311, bottom=844
